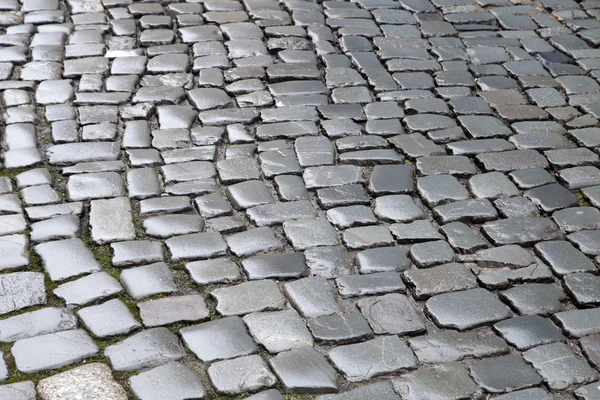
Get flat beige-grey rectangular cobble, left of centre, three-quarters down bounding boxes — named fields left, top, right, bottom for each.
left=211, top=279, right=285, bottom=316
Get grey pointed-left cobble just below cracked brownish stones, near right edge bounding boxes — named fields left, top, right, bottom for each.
left=500, top=283, right=567, bottom=315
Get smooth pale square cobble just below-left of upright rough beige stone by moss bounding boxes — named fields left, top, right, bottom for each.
left=35, top=239, right=101, bottom=281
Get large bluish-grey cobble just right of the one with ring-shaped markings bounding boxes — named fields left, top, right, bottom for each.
left=425, top=289, right=511, bottom=331
